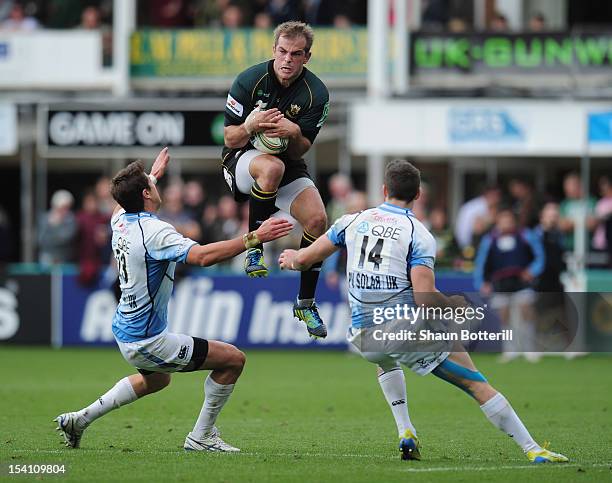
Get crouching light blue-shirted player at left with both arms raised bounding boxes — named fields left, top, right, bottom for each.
left=55, top=148, right=292, bottom=452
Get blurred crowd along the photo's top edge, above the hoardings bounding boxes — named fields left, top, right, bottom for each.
left=0, top=0, right=610, bottom=32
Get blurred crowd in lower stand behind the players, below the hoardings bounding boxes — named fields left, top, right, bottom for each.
left=0, top=173, right=612, bottom=289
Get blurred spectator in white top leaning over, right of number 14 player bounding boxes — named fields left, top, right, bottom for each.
left=455, top=185, right=501, bottom=250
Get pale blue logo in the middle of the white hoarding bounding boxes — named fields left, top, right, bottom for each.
left=448, top=107, right=526, bottom=145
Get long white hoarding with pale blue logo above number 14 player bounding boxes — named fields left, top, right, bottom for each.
left=349, top=99, right=612, bottom=156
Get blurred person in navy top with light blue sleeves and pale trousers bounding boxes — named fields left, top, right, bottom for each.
left=474, top=209, right=544, bottom=362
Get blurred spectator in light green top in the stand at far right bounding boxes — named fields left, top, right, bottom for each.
left=559, top=173, right=597, bottom=250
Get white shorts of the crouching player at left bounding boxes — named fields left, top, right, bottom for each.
left=115, top=330, right=203, bottom=372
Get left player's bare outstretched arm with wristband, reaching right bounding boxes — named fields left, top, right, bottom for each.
left=187, top=218, right=293, bottom=267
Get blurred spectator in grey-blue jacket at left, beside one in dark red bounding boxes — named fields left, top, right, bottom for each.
left=38, top=190, right=77, bottom=266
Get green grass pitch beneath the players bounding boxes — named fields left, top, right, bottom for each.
left=0, top=347, right=612, bottom=483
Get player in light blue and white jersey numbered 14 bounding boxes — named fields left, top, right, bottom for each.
left=279, top=160, right=568, bottom=463
